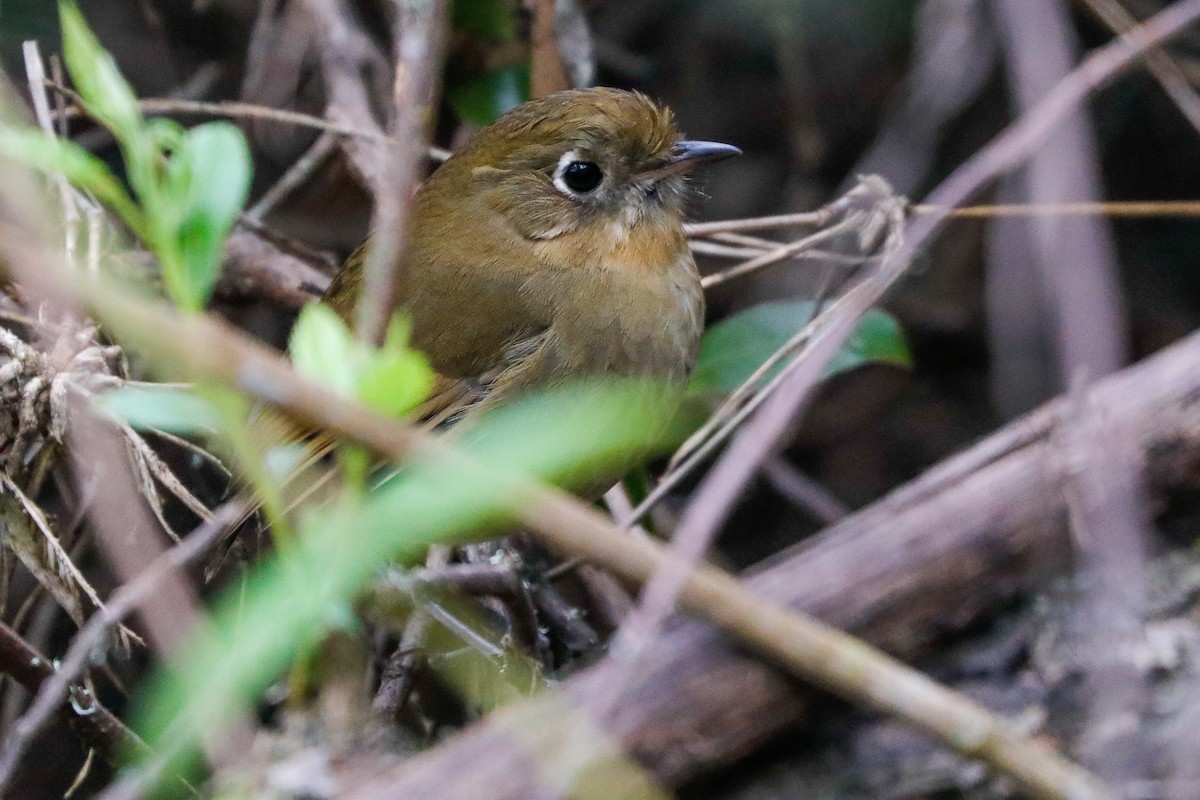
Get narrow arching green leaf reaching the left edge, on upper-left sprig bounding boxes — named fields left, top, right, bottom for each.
left=0, top=128, right=145, bottom=235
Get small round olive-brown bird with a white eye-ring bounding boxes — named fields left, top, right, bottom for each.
left=324, top=89, right=740, bottom=416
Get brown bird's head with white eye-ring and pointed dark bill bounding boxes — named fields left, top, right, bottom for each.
left=430, top=89, right=740, bottom=240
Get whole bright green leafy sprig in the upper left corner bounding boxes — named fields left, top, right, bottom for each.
left=0, top=0, right=251, bottom=311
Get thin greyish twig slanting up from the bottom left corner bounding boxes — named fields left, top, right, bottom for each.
left=0, top=501, right=242, bottom=796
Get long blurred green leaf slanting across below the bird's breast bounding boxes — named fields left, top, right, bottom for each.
left=132, top=381, right=686, bottom=782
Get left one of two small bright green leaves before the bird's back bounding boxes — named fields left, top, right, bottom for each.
left=288, top=303, right=366, bottom=397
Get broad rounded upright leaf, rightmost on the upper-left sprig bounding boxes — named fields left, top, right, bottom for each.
left=164, top=122, right=251, bottom=311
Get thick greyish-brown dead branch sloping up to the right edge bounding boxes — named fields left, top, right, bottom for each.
left=340, top=326, right=1200, bottom=800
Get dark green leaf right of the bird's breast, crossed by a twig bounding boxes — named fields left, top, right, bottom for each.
left=688, top=300, right=912, bottom=395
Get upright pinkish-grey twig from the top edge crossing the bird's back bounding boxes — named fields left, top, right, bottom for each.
left=355, top=0, right=449, bottom=344
